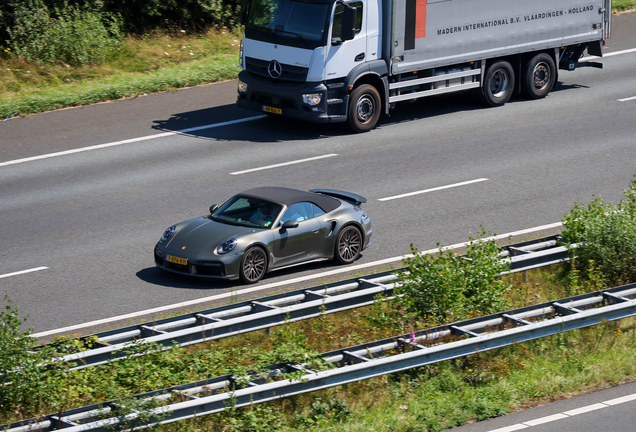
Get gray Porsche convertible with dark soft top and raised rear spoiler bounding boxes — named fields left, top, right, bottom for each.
left=154, top=187, right=371, bottom=283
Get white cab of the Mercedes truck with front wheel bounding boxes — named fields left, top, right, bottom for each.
left=237, top=0, right=388, bottom=129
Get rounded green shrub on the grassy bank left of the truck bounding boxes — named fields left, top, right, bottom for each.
left=8, top=0, right=123, bottom=66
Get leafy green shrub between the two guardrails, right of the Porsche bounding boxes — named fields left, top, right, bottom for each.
left=398, top=229, right=510, bottom=322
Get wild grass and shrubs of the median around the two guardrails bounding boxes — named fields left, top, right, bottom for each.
left=0, top=182, right=636, bottom=432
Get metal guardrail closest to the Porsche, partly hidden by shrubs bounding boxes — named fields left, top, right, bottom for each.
left=46, top=236, right=568, bottom=370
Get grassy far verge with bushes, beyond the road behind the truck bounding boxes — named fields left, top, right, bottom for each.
left=0, top=0, right=636, bottom=119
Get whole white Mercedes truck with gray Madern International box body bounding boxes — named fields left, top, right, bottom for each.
left=237, top=0, right=611, bottom=132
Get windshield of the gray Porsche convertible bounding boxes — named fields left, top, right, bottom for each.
left=212, top=195, right=283, bottom=228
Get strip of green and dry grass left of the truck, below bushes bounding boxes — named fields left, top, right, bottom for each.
left=0, top=29, right=240, bottom=118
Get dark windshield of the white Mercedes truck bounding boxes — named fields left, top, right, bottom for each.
left=245, top=0, right=332, bottom=50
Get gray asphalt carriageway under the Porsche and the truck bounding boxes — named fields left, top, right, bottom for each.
left=0, top=14, right=636, bottom=338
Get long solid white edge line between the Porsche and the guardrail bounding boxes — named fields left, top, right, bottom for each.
left=31, top=222, right=562, bottom=338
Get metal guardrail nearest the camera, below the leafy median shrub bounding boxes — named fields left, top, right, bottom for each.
left=8, top=284, right=636, bottom=432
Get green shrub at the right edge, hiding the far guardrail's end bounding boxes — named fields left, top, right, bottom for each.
left=561, top=180, right=636, bottom=285
